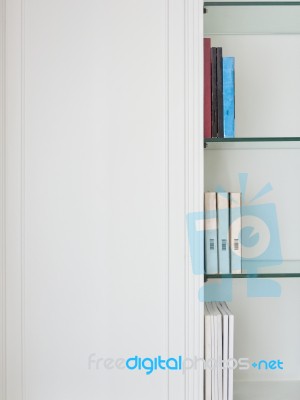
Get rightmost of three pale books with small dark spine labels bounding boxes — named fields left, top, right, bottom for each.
left=229, top=193, right=242, bottom=274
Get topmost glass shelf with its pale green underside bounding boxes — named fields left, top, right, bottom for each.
left=204, top=1, right=300, bottom=35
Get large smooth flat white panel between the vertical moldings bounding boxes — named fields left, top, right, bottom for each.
left=25, top=1, right=168, bottom=399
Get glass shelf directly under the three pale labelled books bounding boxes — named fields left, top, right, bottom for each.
left=205, top=260, right=300, bottom=280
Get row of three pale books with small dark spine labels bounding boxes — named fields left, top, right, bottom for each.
left=204, top=192, right=242, bottom=275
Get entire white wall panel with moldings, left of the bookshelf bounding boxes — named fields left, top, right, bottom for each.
left=1, top=0, right=202, bottom=400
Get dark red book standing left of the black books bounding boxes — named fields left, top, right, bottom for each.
left=203, top=38, right=212, bottom=138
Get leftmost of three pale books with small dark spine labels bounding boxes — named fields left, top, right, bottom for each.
left=204, top=192, right=218, bottom=274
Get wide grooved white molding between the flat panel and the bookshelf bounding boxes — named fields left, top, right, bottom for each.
left=168, top=0, right=203, bottom=400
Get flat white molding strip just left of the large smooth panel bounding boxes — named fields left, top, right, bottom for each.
left=5, top=0, right=24, bottom=400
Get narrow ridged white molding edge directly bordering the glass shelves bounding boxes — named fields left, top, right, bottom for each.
left=184, top=0, right=203, bottom=400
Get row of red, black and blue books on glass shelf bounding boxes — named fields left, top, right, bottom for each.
left=204, top=38, right=235, bottom=138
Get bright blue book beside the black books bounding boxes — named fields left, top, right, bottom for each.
left=223, top=57, right=235, bottom=138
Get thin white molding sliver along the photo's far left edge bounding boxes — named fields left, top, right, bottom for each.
left=0, top=0, right=6, bottom=400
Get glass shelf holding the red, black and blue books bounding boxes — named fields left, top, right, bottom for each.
left=204, top=137, right=300, bottom=150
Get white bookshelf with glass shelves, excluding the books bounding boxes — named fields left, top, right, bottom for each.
left=203, top=1, right=300, bottom=400
